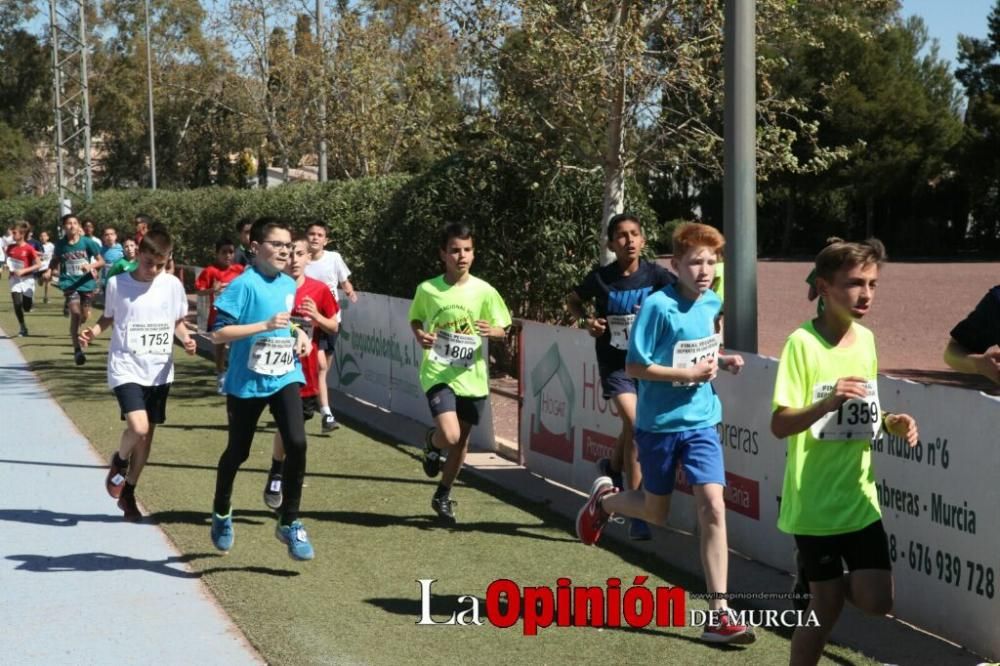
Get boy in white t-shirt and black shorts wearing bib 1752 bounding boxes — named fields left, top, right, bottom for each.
left=80, top=230, right=196, bottom=522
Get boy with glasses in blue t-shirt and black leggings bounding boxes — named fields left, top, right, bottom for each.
left=211, top=218, right=313, bottom=560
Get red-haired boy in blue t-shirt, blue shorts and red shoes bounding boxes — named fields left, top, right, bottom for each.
left=576, top=223, right=756, bottom=644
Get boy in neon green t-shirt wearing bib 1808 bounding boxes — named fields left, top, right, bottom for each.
left=410, top=223, right=511, bottom=523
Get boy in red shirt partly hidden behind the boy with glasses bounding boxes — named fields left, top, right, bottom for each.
left=264, top=236, right=340, bottom=511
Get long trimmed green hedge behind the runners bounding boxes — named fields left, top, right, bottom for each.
left=0, top=154, right=656, bottom=321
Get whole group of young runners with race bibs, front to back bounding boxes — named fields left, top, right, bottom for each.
left=7, top=206, right=944, bottom=664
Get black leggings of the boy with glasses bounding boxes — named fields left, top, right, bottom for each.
left=214, top=383, right=306, bottom=525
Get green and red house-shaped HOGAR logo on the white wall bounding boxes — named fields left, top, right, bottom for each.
left=528, top=342, right=576, bottom=463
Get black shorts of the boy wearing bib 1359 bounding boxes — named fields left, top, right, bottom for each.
left=795, top=520, right=892, bottom=583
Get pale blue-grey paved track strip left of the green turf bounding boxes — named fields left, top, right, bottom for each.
left=0, top=328, right=262, bottom=666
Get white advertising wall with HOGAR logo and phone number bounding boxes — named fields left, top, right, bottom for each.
left=520, top=322, right=1000, bottom=658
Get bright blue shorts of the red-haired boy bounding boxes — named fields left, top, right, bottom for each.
left=635, top=428, right=726, bottom=495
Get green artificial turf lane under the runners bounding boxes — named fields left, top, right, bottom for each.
left=0, top=300, right=873, bottom=665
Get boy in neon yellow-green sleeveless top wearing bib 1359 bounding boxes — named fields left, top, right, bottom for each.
left=771, top=239, right=918, bottom=665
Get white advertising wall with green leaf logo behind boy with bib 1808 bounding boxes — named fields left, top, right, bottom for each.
left=327, top=292, right=496, bottom=451
